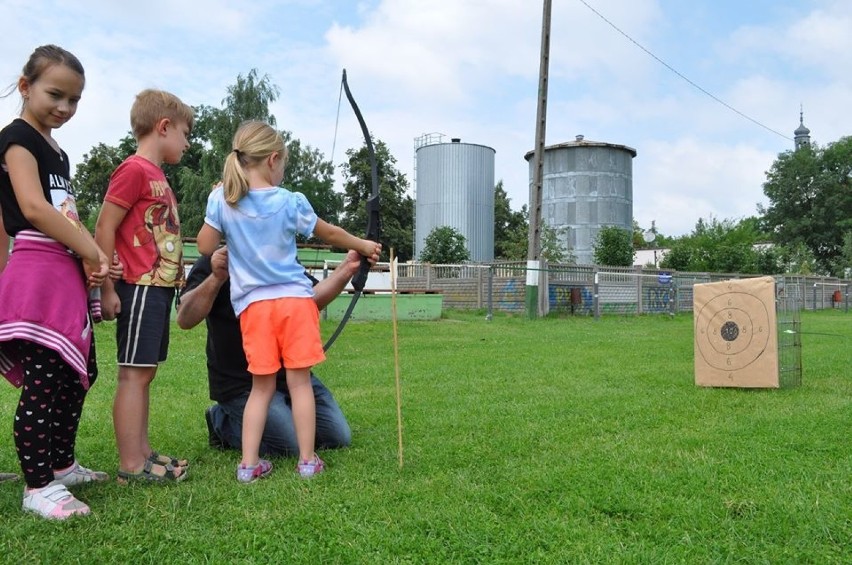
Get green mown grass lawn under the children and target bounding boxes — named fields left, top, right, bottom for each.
left=0, top=311, right=852, bottom=564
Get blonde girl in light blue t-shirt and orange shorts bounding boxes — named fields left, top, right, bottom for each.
left=198, top=121, right=381, bottom=483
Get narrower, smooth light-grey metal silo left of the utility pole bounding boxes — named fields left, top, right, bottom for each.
left=414, top=135, right=495, bottom=261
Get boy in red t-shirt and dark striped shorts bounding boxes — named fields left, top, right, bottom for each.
left=95, top=90, right=193, bottom=482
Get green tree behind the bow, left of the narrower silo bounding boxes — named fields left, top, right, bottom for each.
left=340, top=140, right=414, bottom=261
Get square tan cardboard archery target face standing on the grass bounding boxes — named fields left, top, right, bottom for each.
left=693, top=277, right=778, bottom=388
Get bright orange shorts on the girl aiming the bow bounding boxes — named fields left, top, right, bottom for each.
left=240, top=298, right=325, bottom=375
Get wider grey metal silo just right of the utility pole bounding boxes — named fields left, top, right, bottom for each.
left=524, top=139, right=636, bottom=265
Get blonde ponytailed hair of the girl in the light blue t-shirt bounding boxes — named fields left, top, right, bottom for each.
left=222, top=121, right=289, bottom=206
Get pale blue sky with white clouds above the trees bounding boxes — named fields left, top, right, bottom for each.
left=0, top=0, right=852, bottom=236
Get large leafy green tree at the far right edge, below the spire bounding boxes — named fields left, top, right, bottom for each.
left=758, top=137, right=852, bottom=275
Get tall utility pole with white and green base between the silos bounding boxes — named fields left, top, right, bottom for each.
left=526, top=0, right=551, bottom=318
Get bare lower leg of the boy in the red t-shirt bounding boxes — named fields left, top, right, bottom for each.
left=112, top=366, right=157, bottom=473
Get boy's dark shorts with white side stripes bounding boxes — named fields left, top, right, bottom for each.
left=115, top=281, right=175, bottom=367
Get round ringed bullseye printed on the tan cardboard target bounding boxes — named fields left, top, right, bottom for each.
left=695, top=287, right=769, bottom=371
